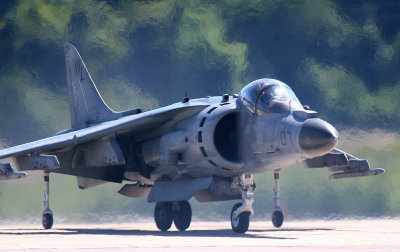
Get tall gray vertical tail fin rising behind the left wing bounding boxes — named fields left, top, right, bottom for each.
left=64, top=43, right=120, bottom=129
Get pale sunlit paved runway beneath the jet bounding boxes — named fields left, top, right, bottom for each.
left=0, top=220, right=400, bottom=251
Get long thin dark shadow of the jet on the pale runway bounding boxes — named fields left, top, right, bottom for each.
left=0, top=228, right=337, bottom=240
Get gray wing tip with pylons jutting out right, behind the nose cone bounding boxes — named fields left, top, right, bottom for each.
left=303, top=149, right=385, bottom=179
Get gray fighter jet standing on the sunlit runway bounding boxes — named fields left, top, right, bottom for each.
left=0, top=43, right=384, bottom=233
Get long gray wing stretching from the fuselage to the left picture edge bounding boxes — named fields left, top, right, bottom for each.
left=0, top=102, right=208, bottom=159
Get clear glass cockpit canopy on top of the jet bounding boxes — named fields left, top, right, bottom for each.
left=239, top=79, right=303, bottom=115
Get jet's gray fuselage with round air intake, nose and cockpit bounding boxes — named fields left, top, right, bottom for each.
left=138, top=79, right=338, bottom=179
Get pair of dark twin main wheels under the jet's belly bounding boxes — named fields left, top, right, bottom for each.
left=154, top=200, right=192, bottom=231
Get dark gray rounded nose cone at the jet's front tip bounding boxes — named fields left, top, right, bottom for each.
left=299, top=118, right=339, bottom=156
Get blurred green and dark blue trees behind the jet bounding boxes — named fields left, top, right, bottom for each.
left=0, top=0, right=400, bottom=222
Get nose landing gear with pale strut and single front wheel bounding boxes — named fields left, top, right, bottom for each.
left=231, top=174, right=255, bottom=233
